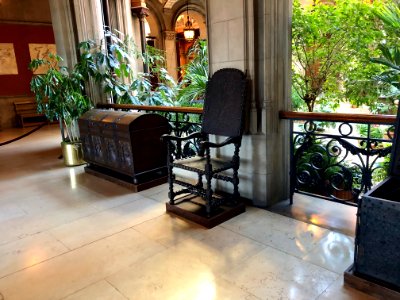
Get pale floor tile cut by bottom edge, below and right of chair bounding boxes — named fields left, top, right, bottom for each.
left=223, top=247, right=339, bottom=300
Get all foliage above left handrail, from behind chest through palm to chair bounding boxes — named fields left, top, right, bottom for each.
left=80, top=31, right=208, bottom=106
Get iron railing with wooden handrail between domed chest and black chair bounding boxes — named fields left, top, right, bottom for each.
left=97, top=104, right=203, bottom=158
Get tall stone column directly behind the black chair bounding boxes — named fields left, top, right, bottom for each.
left=207, top=0, right=291, bottom=207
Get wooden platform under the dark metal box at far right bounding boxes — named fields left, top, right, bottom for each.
left=344, top=265, right=400, bottom=300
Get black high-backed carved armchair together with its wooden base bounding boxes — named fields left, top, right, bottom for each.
left=163, top=69, right=247, bottom=228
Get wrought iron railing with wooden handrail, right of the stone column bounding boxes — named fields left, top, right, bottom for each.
left=280, top=112, right=396, bottom=206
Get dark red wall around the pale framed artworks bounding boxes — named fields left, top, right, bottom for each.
left=0, top=23, right=55, bottom=96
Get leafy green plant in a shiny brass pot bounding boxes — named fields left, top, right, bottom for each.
left=29, top=54, right=92, bottom=166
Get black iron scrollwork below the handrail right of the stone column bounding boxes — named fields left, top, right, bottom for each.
left=291, top=121, right=393, bottom=205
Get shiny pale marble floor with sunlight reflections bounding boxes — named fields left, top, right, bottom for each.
left=0, top=126, right=374, bottom=300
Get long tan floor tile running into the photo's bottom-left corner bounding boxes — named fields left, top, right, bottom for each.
left=0, top=229, right=165, bottom=300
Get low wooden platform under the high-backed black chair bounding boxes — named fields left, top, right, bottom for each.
left=166, top=195, right=246, bottom=228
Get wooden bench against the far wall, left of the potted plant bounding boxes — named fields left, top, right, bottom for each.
left=14, top=100, right=47, bottom=127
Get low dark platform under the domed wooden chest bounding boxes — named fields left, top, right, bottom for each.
left=84, top=165, right=168, bottom=193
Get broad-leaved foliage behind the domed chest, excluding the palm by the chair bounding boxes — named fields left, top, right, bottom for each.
left=76, top=31, right=181, bottom=106
